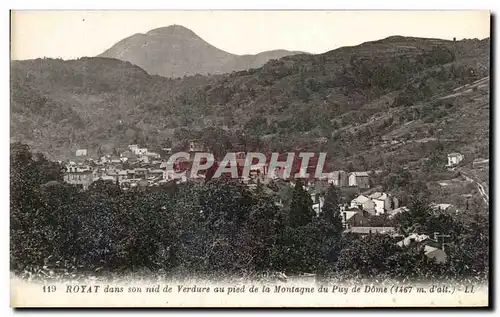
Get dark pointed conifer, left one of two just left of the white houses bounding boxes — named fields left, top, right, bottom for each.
left=289, top=180, right=316, bottom=228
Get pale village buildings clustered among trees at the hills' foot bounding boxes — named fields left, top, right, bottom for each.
left=60, top=140, right=470, bottom=262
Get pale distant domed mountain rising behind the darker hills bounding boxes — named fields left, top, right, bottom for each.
left=99, top=25, right=301, bottom=77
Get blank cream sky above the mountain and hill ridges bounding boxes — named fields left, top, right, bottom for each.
left=11, top=11, right=490, bottom=60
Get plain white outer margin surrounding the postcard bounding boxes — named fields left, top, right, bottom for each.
left=0, top=0, right=500, bottom=316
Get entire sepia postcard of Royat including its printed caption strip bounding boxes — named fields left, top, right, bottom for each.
left=9, top=10, right=492, bottom=308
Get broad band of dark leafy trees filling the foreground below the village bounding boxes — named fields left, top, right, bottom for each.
left=10, top=144, right=489, bottom=278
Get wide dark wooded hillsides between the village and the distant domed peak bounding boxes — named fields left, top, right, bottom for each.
left=11, top=36, right=490, bottom=169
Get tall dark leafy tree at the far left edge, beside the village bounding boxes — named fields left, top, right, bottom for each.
left=10, top=143, right=65, bottom=268
